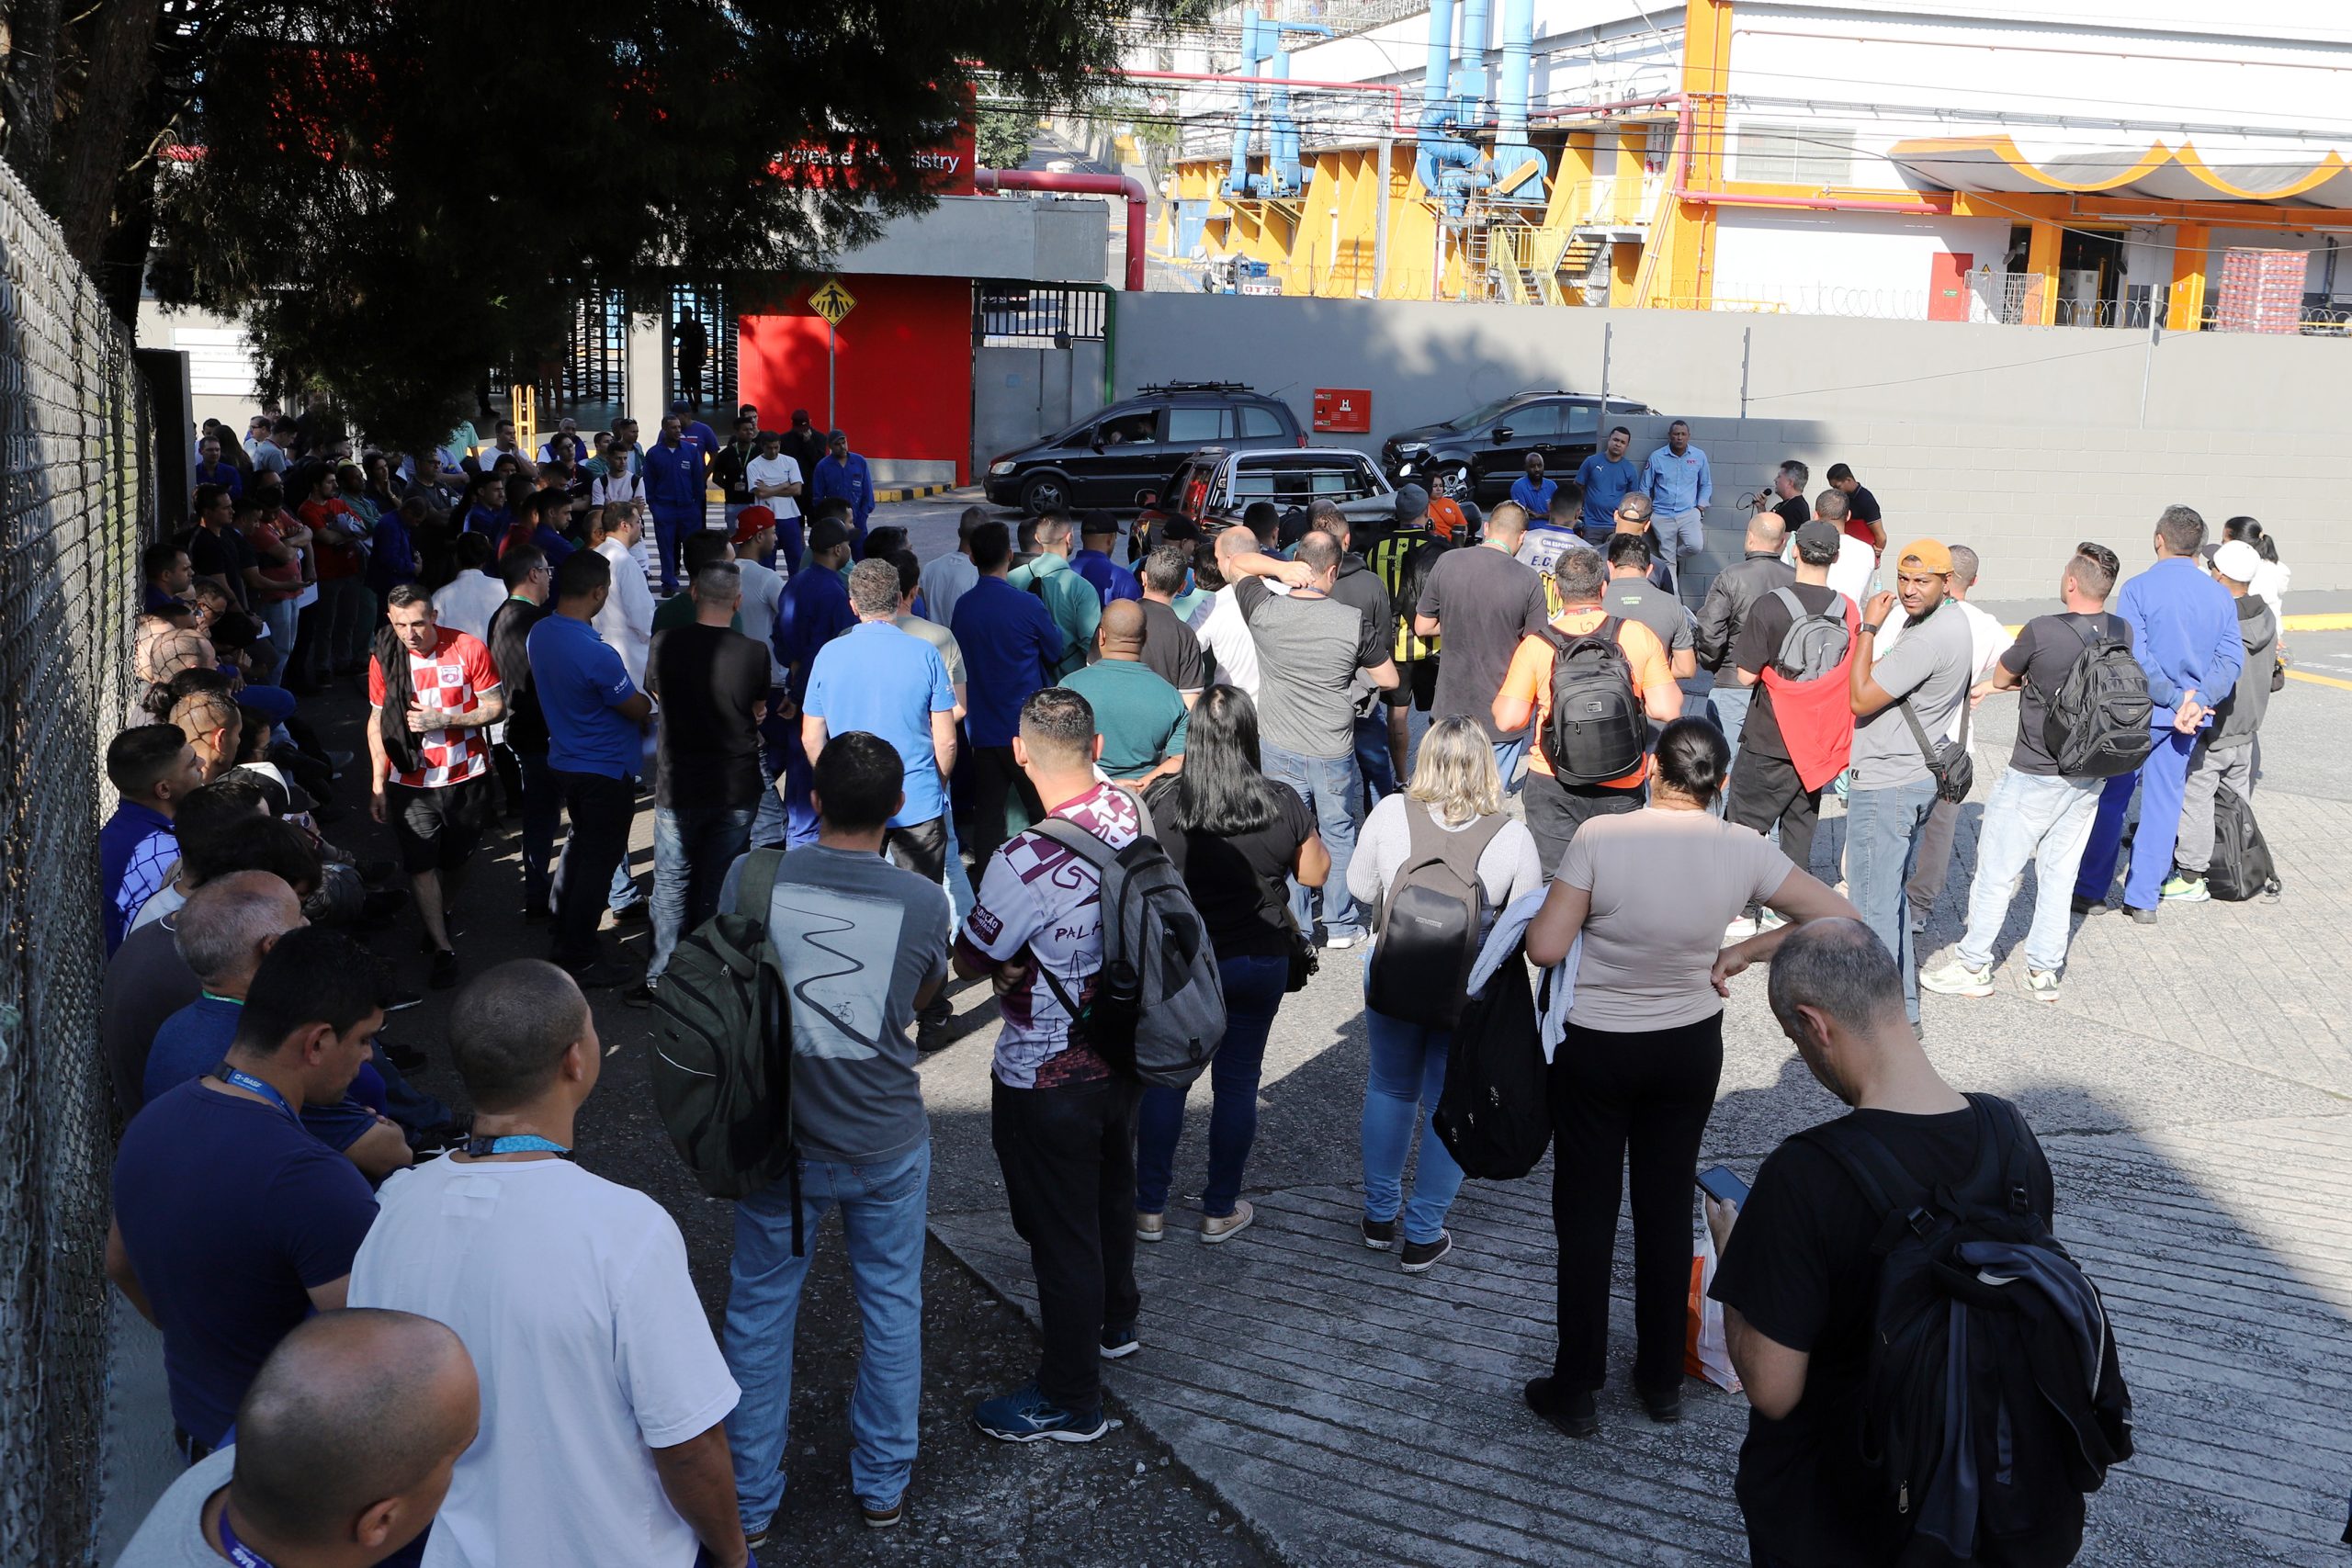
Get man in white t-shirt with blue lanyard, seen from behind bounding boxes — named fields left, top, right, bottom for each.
left=350, top=959, right=751, bottom=1568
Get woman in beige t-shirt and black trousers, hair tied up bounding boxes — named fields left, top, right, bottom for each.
left=1526, top=719, right=1853, bottom=1437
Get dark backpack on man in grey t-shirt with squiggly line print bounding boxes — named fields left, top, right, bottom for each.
left=651, top=849, right=799, bottom=1253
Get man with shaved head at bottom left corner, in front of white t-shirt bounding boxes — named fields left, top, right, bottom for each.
left=115, top=1312, right=480, bottom=1568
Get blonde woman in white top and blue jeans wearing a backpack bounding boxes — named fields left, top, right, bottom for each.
left=1348, top=715, right=1543, bottom=1274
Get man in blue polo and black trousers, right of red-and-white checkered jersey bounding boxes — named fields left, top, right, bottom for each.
left=525, top=550, right=654, bottom=989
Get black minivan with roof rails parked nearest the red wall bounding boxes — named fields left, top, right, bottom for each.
left=983, top=381, right=1307, bottom=513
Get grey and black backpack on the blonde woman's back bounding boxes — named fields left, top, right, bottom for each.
left=1364, top=797, right=1510, bottom=1030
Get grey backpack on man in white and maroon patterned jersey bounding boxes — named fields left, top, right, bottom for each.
left=1035, top=818, right=1226, bottom=1089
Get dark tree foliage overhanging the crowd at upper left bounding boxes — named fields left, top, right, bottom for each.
left=137, top=0, right=1148, bottom=442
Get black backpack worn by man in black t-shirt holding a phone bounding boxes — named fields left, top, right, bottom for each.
left=1797, top=1096, right=2131, bottom=1568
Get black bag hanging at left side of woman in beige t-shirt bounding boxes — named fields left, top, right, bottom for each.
left=1430, top=942, right=1553, bottom=1182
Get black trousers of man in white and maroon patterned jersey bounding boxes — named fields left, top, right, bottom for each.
left=988, top=1077, right=1143, bottom=1413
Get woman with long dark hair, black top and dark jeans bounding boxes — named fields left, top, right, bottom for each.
left=1136, top=686, right=1331, bottom=1244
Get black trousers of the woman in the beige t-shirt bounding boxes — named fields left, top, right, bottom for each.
left=1550, top=1013, right=1724, bottom=1394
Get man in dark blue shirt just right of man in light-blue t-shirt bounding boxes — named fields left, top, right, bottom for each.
left=950, top=522, right=1066, bottom=865
